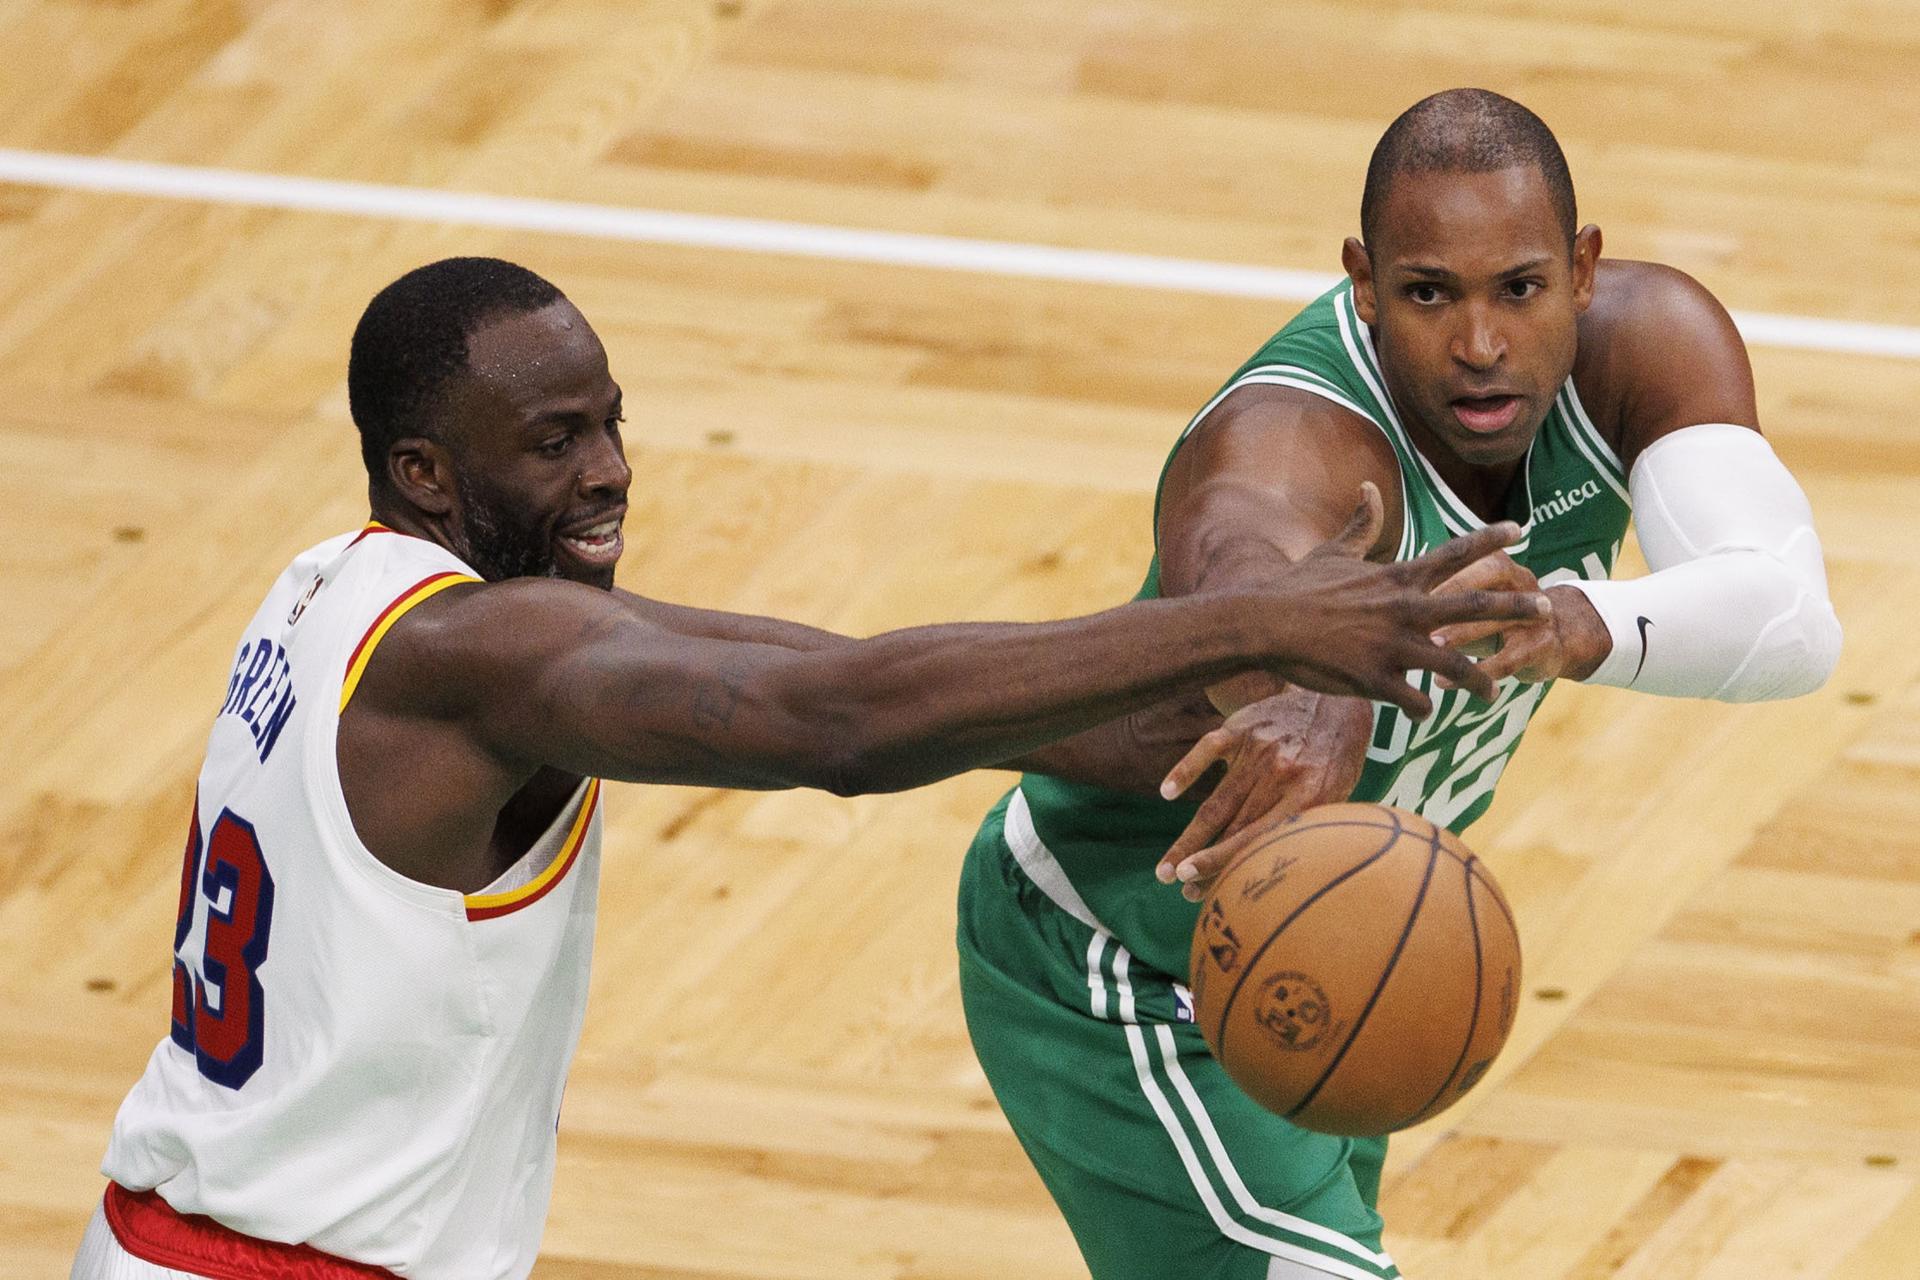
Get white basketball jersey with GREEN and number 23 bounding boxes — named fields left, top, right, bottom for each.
left=102, top=526, right=601, bottom=1280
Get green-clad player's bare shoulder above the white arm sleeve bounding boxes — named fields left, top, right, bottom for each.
left=1574, top=259, right=1759, bottom=468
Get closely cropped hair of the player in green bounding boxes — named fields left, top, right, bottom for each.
left=1359, top=88, right=1578, bottom=249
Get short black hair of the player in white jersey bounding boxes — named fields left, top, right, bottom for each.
left=348, top=257, right=564, bottom=484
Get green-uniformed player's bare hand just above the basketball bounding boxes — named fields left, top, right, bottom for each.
left=1156, top=689, right=1373, bottom=902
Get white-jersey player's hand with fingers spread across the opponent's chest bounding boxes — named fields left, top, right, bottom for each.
left=1269, top=484, right=1553, bottom=720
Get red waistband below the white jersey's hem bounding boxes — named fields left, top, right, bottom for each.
left=106, top=1182, right=396, bottom=1280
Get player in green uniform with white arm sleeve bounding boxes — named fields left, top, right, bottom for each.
left=960, top=90, right=1839, bottom=1280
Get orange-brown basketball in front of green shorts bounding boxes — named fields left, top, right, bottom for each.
left=1190, top=804, right=1521, bottom=1138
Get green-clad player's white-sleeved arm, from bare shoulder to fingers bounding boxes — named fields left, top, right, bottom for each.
left=1446, top=263, right=1841, bottom=702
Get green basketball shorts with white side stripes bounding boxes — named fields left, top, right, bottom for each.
left=960, top=800, right=1400, bottom=1280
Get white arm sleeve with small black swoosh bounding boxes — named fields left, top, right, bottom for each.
left=1567, top=422, right=1839, bottom=702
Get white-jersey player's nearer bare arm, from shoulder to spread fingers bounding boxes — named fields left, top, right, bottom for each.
left=388, top=497, right=1544, bottom=793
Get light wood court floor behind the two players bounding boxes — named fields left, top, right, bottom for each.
left=0, top=0, right=1920, bottom=1280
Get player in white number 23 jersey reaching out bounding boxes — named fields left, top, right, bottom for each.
left=73, top=259, right=1546, bottom=1280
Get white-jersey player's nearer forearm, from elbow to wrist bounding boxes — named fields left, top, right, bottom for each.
left=762, top=595, right=1292, bottom=793
